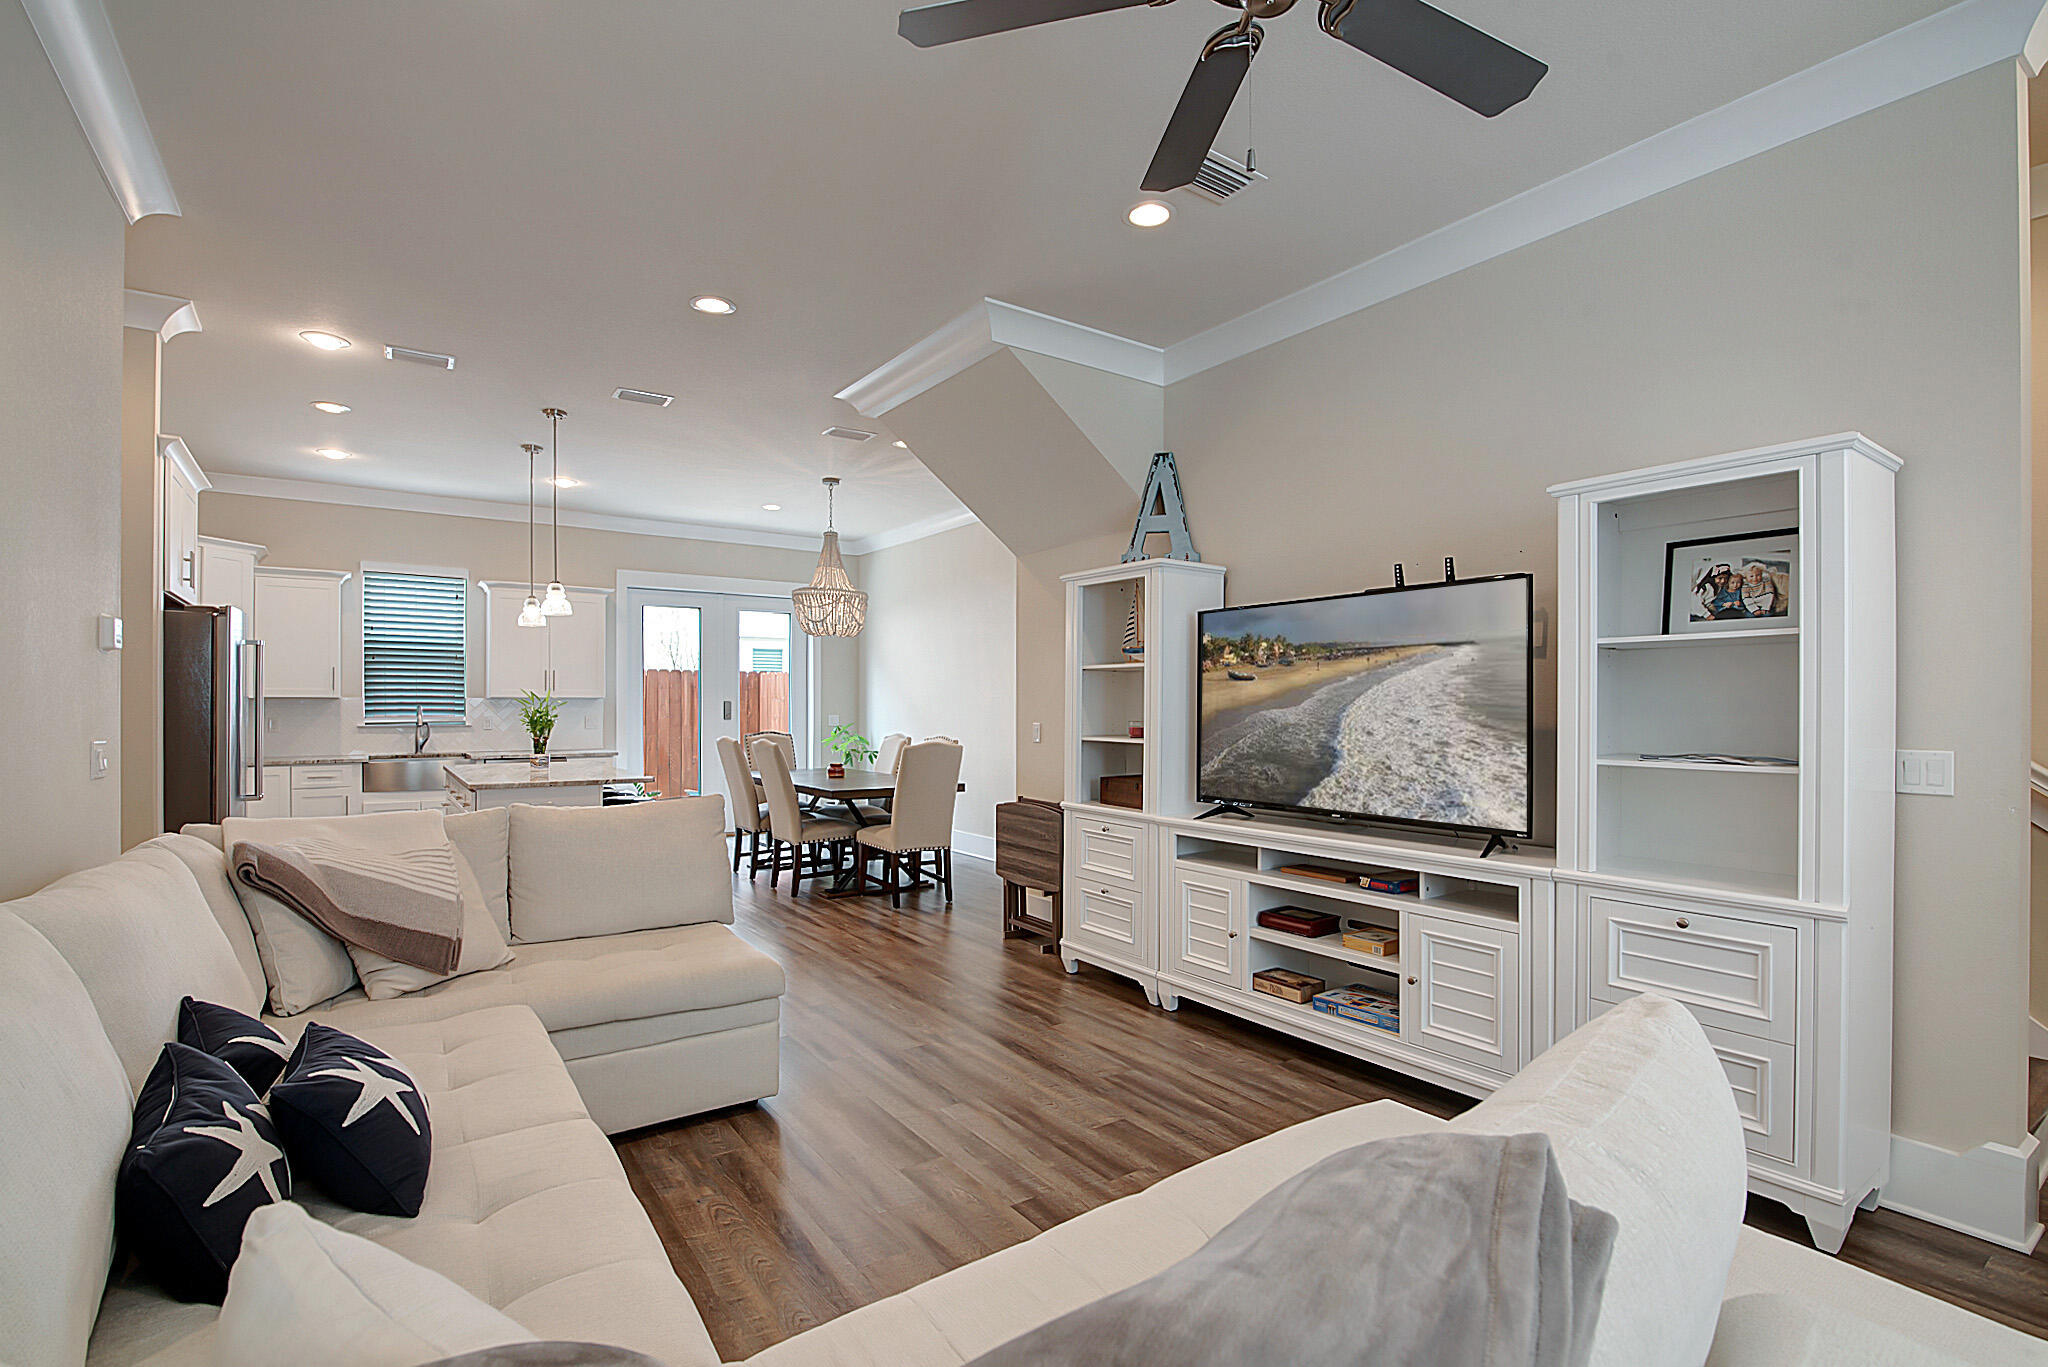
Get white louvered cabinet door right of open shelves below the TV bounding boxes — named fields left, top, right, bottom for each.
left=1401, top=912, right=1522, bottom=1074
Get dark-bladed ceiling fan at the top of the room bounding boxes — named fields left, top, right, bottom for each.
left=897, top=0, right=1550, bottom=193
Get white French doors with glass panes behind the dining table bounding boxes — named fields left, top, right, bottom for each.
left=621, top=588, right=811, bottom=807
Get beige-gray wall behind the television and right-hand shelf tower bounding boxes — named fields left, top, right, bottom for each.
left=1155, top=64, right=2032, bottom=1150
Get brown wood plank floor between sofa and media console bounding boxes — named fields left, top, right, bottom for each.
left=618, top=859, right=2048, bottom=1361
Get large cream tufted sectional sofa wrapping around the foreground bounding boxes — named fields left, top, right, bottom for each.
left=0, top=811, right=2048, bottom=1367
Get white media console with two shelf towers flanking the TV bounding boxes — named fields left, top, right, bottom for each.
left=1059, top=434, right=1898, bottom=1252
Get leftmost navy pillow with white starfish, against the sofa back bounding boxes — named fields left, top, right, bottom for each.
left=115, top=1043, right=291, bottom=1306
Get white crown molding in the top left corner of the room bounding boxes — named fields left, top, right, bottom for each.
left=20, top=0, right=180, bottom=223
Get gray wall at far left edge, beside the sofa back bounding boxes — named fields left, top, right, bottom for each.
left=0, top=13, right=123, bottom=898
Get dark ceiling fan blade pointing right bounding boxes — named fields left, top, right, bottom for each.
left=1323, top=0, right=1550, bottom=119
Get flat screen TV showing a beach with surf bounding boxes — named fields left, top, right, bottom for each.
left=1196, top=574, right=1534, bottom=836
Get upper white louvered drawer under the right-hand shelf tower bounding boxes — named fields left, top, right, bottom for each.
left=1583, top=892, right=1798, bottom=1045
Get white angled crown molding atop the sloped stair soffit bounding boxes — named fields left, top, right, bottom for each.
left=834, top=299, right=1165, bottom=418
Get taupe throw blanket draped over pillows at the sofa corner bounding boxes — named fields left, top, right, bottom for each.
left=231, top=836, right=463, bottom=974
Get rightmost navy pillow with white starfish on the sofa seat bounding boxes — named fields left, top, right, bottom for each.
left=270, top=1025, right=434, bottom=1215
